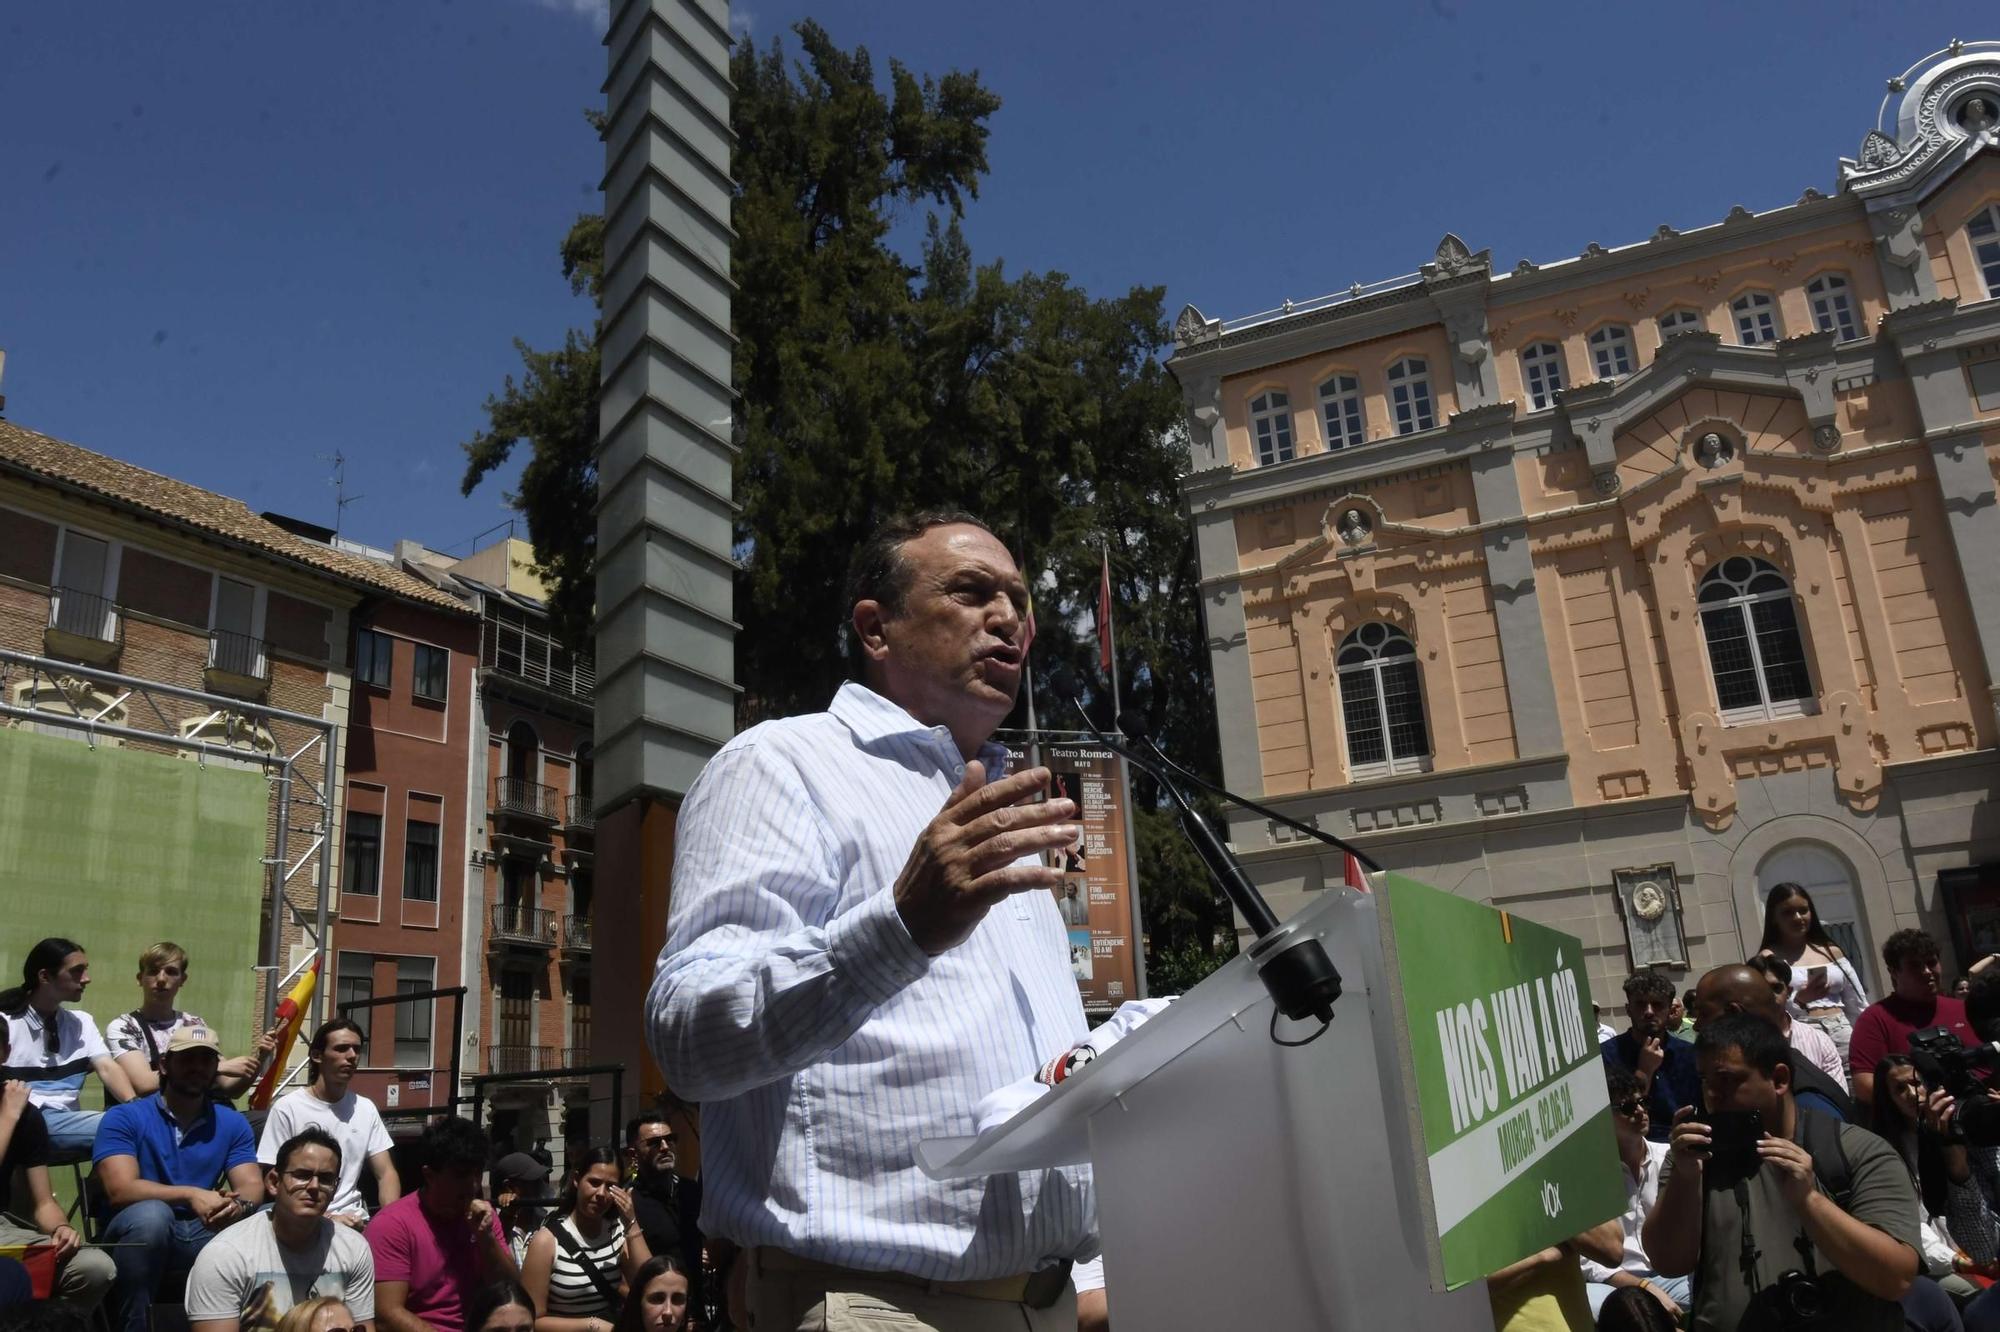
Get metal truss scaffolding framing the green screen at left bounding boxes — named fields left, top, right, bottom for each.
left=0, top=648, right=340, bottom=1026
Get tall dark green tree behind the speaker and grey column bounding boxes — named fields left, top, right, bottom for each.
left=476, top=22, right=1228, bottom=978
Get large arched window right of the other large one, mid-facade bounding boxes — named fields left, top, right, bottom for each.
left=1694, top=556, right=1812, bottom=724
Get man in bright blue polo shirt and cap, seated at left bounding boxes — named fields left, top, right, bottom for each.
left=96, top=1026, right=264, bottom=1332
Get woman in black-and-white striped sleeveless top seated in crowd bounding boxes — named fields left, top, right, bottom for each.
left=520, top=1148, right=652, bottom=1332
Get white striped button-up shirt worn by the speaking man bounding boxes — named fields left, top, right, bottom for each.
left=646, top=684, right=1098, bottom=1280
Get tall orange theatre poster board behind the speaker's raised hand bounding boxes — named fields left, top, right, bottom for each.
left=998, top=732, right=1140, bottom=1012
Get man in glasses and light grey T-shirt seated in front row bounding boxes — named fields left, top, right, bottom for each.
left=186, top=1128, right=374, bottom=1332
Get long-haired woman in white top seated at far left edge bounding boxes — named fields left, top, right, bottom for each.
left=0, top=938, right=132, bottom=1160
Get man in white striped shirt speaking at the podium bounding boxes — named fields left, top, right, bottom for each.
left=646, top=512, right=1098, bottom=1332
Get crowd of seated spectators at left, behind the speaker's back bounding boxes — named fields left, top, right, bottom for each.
left=0, top=938, right=702, bottom=1332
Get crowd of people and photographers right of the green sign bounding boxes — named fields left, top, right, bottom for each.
left=1552, top=884, right=2000, bottom=1332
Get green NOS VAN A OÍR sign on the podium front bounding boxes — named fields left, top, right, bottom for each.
left=1378, top=874, right=1626, bottom=1290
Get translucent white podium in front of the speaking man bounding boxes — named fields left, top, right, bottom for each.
left=918, top=888, right=1492, bottom=1332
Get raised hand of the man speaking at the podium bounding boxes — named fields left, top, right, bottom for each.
left=896, top=760, right=1076, bottom=956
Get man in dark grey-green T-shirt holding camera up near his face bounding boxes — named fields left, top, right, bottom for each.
left=1644, top=1012, right=1920, bottom=1332
